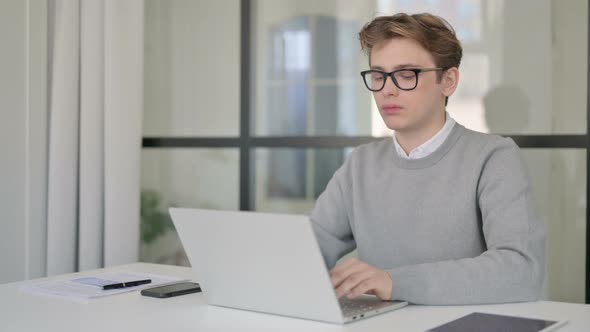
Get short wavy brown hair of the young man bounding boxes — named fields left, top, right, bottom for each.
left=359, top=13, right=463, bottom=69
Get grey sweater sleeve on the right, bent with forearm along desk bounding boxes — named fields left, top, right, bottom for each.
left=387, top=139, right=545, bottom=305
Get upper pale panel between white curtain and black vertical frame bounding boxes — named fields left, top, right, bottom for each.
left=143, top=0, right=240, bottom=136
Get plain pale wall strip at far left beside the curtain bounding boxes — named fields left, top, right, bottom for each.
left=0, top=0, right=47, bottom=283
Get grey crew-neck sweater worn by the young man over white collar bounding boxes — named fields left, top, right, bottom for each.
left=310, top=123, right=545, bottom=305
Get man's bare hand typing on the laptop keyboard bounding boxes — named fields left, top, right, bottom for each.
left=330, top=258, right=393, bottom=300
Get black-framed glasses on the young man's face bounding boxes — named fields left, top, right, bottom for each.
left=361, top=68, right=444, bottom=92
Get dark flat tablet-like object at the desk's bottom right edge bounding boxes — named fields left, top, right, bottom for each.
left=428, top=312, right=566, bottom=332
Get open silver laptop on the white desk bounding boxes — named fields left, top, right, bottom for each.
left=170, top=208, right=407, bottom=323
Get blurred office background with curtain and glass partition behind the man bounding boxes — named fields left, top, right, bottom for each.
left=0, top=0, right=589, bottom=303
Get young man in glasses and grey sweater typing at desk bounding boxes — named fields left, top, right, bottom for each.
left=310, top=14, right=545, bottom=304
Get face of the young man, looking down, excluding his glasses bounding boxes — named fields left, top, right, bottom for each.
left=371, top=38, right=445, bottom=133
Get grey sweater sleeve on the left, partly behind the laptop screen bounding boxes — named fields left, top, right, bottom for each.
left=310, top=153, right=356, bottom=269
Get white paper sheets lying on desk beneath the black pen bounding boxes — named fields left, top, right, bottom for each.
left=21, top=272, right=183, bottom=301
